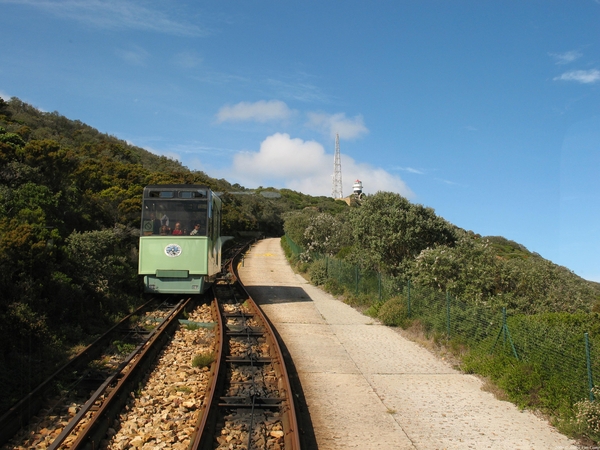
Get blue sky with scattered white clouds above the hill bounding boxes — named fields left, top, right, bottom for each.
left=0, top=0, right=600, bottom=281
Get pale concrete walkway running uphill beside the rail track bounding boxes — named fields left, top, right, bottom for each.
left=239, top=239, right=577, bottom=450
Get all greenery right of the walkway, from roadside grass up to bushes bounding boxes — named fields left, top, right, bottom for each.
left=282, top=192, right=600, bottom=441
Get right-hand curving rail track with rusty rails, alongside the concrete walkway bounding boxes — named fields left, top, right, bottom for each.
left=192, top=244, right=300, bottom=450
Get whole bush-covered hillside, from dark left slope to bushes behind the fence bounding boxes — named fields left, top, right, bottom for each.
left=0, top=98, right=600, bottom=424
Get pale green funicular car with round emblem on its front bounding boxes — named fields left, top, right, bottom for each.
left=138, top=184, right=222, bottom=294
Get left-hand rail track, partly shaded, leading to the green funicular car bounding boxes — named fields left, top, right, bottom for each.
left=2, top=300, right=198, bottom=449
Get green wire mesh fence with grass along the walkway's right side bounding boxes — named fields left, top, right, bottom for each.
left=286, top=237, right=600, bottom=410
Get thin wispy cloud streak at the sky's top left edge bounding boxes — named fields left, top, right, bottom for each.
left=0, top=0, right=204, bottom=36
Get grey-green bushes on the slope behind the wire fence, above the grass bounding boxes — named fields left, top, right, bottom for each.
left=284, top=192, right=600, bottom=314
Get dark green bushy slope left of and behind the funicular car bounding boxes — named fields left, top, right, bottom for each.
left=0, top=98, right=345, bottom=414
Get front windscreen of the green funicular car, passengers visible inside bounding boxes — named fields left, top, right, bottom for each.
left=142, top=200, right=208, bottom=236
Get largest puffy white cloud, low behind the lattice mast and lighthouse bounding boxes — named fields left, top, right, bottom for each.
left=227, top=133, right=414, bottom=198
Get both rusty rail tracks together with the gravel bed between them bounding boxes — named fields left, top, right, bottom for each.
left=0, top=243, right=300, bottom=450
